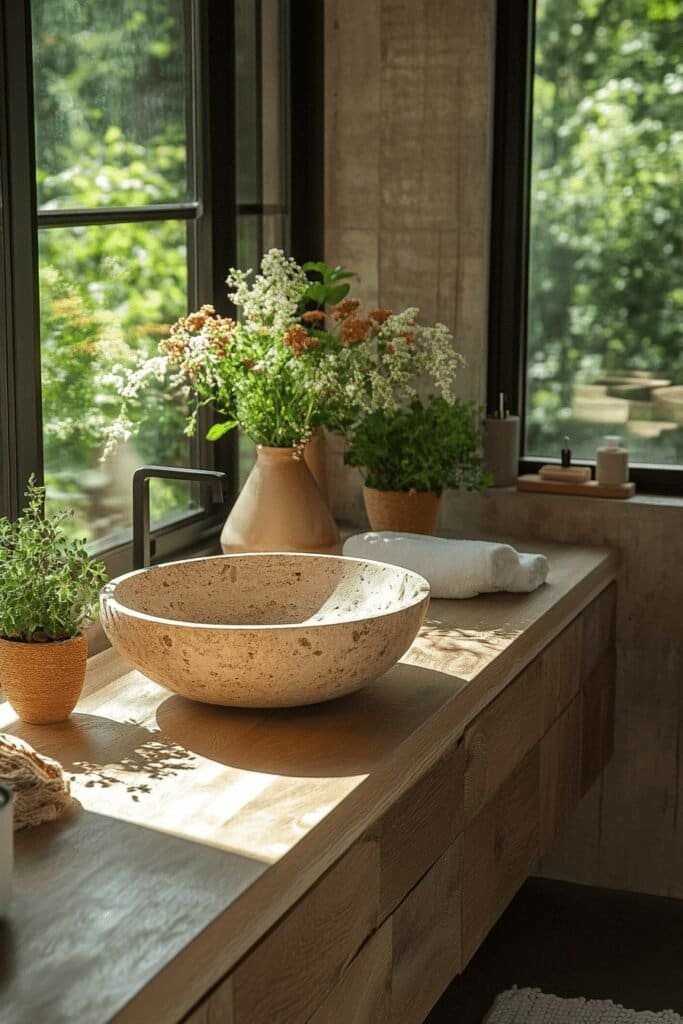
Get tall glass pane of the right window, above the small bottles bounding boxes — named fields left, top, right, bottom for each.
left=526, top=0, right=683, bottom=465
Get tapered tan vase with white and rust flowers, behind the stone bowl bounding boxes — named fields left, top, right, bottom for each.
left=110, top=249, right=353, bottom=553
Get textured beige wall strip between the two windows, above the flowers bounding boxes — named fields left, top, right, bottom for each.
left=326, top=0, right=493, bottom=400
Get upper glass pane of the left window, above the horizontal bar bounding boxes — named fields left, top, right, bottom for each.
left=31, top=0, right=191, bottom=208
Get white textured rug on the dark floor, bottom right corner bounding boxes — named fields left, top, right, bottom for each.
left=484, top=988, right=683, bottom=1024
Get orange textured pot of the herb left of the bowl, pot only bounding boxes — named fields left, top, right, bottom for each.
left=0, top=634, right=88, bottom=725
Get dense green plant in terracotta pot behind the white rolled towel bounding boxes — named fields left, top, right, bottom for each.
left=345, top=394, right=487, bottom=534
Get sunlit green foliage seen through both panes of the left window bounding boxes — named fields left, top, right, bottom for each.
left=32, top=0, right=194, bottom=543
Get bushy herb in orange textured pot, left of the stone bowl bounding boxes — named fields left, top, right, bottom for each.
left=0, top=476, right=106, bottom=725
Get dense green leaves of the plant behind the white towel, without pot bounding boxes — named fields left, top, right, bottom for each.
left=345, top=395, right=489, bottom=495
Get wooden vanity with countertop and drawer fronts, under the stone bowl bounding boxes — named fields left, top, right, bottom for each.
left=0, top=544, right=617, bottom=1024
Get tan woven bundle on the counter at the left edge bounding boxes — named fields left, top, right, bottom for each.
left=0, top=732, right=73, bottom=831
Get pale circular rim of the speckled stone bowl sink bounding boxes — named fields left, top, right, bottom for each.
left=99, top=551, right=430, bottom=633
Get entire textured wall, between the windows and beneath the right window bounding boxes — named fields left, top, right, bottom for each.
left=326, top=0, right=683, bottom=898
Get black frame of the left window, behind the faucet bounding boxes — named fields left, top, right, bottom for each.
left=0, top=0, right=324, bottom=574
